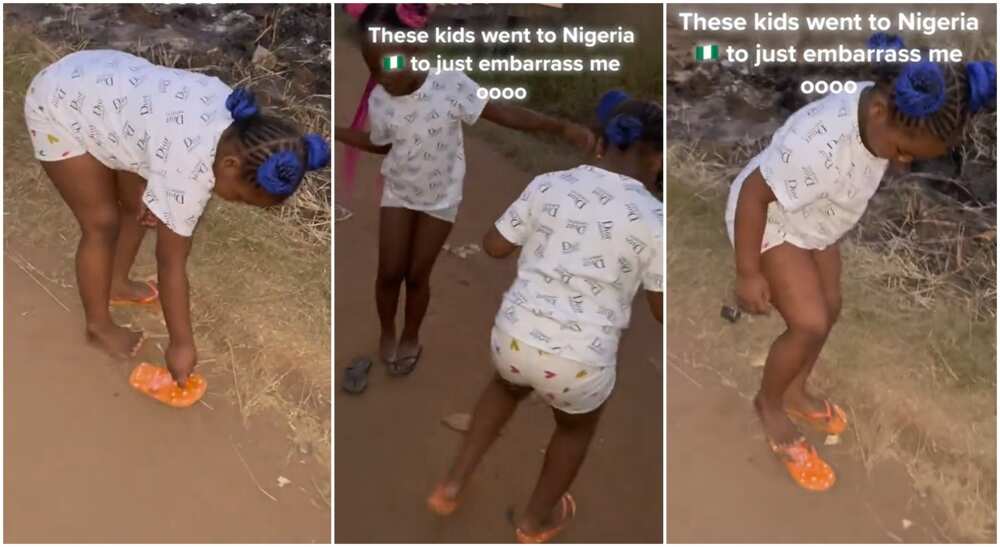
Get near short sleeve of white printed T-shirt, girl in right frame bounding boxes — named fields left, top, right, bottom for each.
left=760, top=104, right=841, bottom=211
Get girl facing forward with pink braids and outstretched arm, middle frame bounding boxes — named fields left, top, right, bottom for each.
left=334, top=4, right=594, bottom=382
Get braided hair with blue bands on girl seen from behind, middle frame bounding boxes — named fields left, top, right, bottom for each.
left=597, top=89, right=663, bottom=152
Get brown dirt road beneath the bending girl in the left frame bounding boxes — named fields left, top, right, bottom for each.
left=3, top=244, right=330, bottom=543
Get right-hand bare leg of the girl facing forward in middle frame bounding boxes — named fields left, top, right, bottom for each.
left=396, top=213, right=454, bottom=358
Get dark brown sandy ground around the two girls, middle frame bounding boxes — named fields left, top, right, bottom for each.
left=334, top=37, right=663, bottom=543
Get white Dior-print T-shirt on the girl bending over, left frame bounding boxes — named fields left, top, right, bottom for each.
left=38, top=50, right=233, bottom=236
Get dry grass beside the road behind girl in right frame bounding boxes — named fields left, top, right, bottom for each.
left=667, top=145, right=997, bottom=542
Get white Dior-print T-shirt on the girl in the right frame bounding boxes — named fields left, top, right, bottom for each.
left=726, top=82, right=889, bottom=249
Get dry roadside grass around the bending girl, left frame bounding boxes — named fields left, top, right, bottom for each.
left=4, top=26, right=331, bottom=480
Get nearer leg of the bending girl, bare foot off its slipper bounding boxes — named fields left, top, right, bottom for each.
left=41, top=154, right=142, bottom=356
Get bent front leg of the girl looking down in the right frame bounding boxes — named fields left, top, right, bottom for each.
left=754, top=243, right=830, bottom=444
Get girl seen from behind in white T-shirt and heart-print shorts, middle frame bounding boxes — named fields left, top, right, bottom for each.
left=427, top=91, right=664, bottom=543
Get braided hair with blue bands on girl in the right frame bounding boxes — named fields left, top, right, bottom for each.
left=868, top=33, right=996, bottom=143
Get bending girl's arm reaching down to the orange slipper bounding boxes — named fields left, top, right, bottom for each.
left=156, top=222, right=198, bottom=387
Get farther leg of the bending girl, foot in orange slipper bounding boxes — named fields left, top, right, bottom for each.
left=111, top=171, right=152, bottom=300
